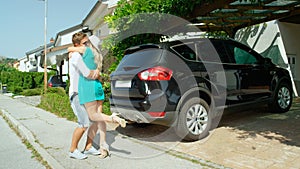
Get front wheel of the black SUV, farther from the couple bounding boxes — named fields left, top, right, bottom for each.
left=269, top=82, right=293, bottom=113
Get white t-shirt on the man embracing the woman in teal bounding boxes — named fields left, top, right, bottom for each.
left=69, top=52, right=90, bottom=97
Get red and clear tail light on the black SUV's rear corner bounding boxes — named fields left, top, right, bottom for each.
left=138, top=66, right=173, bottom=81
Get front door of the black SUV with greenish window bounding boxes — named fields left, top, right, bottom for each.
left=224, top=41, right=272, bottom=102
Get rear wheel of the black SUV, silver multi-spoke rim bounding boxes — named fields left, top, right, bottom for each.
left=175, top=97, right=212, bottom=141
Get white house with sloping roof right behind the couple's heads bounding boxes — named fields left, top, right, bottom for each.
left=47, top=0, right=119, bottom=75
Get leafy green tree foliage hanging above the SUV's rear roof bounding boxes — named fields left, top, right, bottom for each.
left=103, top=0, right=206, bottom=70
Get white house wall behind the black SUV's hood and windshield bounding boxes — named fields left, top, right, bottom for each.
left=235, top=20, right=300, bottom=96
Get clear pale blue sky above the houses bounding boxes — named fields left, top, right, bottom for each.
left=0, top=0, right=98, bottom=59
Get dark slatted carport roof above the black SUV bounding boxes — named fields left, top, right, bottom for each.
left=186, top=0, right=300, bottom=34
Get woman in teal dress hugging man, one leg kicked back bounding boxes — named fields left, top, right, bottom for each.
left=68, top=34, right=126, bottom=158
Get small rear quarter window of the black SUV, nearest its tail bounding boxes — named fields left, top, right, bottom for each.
left=171, top=43, right=197, bottom=61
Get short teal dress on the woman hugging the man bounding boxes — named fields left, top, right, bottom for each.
left=78, top=47, right=104, bottom=104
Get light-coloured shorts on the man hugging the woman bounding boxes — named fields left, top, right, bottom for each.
left=70, top=94, right=90, bottom=127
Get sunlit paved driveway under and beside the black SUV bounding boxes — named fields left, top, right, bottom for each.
left=118, top=99, right=300, bottom=169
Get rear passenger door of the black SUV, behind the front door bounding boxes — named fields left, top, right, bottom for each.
left=197, top=39, right=240, bottom=106
